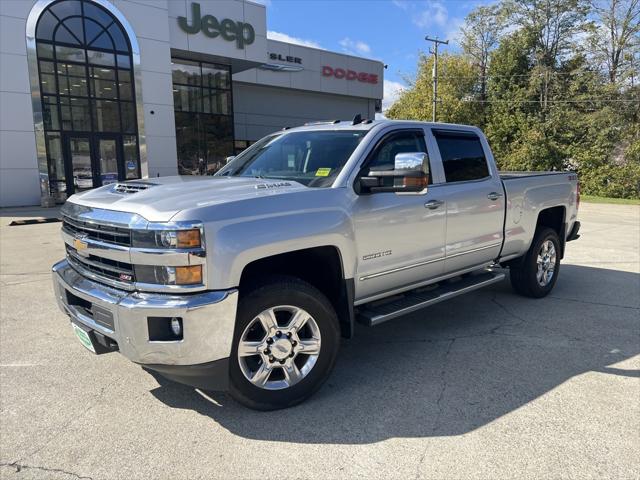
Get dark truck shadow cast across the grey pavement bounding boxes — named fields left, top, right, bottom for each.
left=146, top=265, right=640, bottom=444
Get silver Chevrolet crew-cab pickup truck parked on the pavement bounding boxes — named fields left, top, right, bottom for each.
left=53, top=120, right=580, bottom=409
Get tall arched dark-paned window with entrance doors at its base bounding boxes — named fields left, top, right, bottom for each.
left=35, top=0, right=140, bottom=199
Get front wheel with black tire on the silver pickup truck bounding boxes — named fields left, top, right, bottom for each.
left=229, top=276, right=340, bottom=410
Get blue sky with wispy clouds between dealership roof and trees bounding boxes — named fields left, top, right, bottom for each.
left=259, top=0, right=482, bottom=110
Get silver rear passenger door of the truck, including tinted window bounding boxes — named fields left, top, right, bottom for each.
left=432, top=129, right=504, bottom=273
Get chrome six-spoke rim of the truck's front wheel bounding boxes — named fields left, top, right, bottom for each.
left=238, top=305, right=320, bottom=390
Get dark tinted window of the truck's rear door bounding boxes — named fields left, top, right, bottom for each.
left=433, top=131, right=489, bottom=183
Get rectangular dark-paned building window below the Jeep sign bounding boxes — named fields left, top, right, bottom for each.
left=171, top=58, right=234, bottom=175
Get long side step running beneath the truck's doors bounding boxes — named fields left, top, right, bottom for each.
left=358, top=272, right=506, bottom=327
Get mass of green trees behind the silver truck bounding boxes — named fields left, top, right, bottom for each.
left=386, top=0, right=640, bottom=199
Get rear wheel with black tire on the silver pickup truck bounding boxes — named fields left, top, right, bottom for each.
left=509, top=228, right=560, bottom=298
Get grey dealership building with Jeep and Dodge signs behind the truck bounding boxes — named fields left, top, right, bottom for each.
left=0, top=0, right=383, bottom=207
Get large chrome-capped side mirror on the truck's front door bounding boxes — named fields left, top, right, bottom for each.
left=359, top=152, right=429, bottom=193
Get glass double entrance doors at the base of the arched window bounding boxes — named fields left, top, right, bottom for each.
left=64, top=134, right=125, bottom=195
